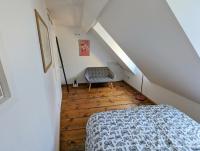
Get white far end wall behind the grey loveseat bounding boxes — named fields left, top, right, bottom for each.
left=56, top=26, right=123, bottom=83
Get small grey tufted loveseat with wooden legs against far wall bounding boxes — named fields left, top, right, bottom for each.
left=85, top=67, right=114, bottom=91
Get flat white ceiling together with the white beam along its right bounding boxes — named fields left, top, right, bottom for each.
left=46, top=0, right=110, bottom=28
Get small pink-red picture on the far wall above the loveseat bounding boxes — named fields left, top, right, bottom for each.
left=79, top=40, right=90, bottom=56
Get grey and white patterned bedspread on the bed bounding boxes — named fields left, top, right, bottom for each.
left=85, top=105, right=200, bottom=151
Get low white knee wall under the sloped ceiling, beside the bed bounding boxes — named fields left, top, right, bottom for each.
left=124, top=71, right=200, bottom=122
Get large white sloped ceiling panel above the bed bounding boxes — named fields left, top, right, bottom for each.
left=99, top=0, right=200, bottom=102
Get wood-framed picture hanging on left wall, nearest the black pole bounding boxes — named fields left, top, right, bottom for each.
left=35, top=10, right=52, bottom=73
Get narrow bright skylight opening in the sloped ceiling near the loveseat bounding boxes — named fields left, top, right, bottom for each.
left=93, top=23, right=137, bottom=74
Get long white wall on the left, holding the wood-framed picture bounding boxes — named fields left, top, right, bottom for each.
left=0, top=0, right=61, bottom=151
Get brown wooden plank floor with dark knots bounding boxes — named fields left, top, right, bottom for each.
left=60, top=82, right=153, bottom=151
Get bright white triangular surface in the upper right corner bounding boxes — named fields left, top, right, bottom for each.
left=167, top=0, right=200, bottom=56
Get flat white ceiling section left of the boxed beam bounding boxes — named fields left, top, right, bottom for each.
left=46, top=0, right=84, bottom=27
